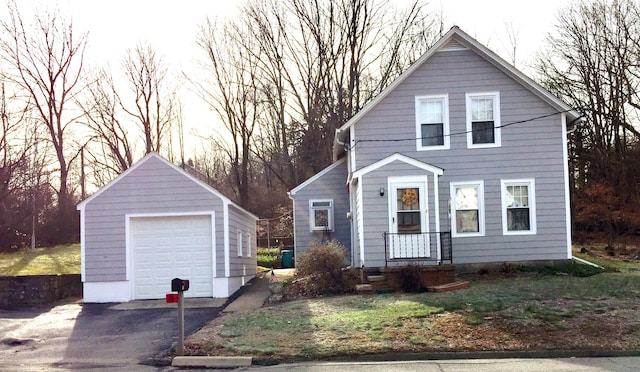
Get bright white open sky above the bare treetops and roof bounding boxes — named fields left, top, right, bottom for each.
left=8, top=0, right=571, bottom=154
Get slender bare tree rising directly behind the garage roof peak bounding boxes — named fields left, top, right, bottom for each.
left=123, top=44, right=175, bottom=154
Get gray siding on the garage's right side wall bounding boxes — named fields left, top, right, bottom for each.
left=228, top=206, right=257, bottom=277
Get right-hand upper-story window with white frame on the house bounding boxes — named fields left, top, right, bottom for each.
left=466, top=92, right=500, bottom=148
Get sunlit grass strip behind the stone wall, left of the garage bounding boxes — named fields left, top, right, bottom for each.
left=0, top=244, right=80, bottom=276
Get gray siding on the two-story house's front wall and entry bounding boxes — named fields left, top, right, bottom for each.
left=353, top=50, right=567, bottom=263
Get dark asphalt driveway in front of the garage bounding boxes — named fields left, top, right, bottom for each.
left=0, top=299, right=225, bottom=371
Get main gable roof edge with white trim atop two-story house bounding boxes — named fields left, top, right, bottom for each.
left=333, top=26, right=582, bottom=156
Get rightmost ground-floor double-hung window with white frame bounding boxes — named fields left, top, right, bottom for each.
left=501, top=179, right=536, bottom=235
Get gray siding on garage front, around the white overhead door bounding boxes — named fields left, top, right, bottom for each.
left=84, top=157, right=224, bottom=282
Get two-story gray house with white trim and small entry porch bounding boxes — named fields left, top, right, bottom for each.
left=290, top=27, right=580, bottom=267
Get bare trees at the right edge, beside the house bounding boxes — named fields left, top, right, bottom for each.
left=537, top=0, right=640, bottom=246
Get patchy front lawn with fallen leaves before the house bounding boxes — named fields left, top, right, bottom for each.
left=186, top=256, right=640, bottom=362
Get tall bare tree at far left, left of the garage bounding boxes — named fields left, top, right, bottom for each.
left=0, top=2, right=87, bottom=241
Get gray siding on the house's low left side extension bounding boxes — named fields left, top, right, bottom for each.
left=294, top=162, right=351, bottom=256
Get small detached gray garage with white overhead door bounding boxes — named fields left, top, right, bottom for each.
left=78, top=153, right=258, bottom=302
